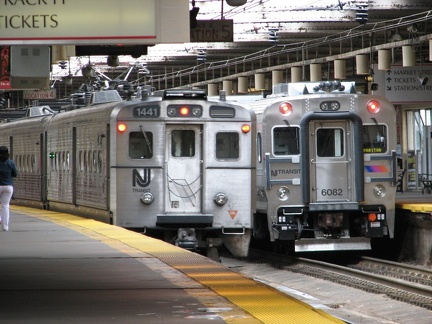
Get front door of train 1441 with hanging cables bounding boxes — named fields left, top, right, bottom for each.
left=165, top=125, right=202, bottom=213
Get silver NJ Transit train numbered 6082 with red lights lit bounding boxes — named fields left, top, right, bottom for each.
left=250, top=81, right=397, bottom=252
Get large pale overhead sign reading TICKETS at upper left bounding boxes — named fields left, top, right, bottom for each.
left=0, top=0, right=185, bottom=45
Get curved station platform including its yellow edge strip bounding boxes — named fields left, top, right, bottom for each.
left=0, top=206, right=344, bottom=324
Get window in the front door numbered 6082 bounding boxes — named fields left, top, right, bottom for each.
left=316, top=128, right=344, bottom=157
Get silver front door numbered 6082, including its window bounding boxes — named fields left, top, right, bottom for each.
left=309, top=120, right=355, bottom=204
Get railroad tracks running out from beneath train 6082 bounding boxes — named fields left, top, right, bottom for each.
left=241, top=250, right=432, bottom=310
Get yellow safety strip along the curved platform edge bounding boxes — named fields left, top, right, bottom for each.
left=11, top=205, right=344, bottom=324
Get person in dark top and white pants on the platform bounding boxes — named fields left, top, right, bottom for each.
left=0, top=146, right=18, bottom=231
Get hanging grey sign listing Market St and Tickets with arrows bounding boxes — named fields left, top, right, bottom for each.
left=373, top=64, right=432, bottom=104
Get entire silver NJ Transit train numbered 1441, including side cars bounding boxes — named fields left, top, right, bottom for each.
left=0, top=90, right=256, bottom=256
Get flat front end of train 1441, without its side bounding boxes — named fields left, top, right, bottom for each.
left=111, top=90, right=255, bottom=256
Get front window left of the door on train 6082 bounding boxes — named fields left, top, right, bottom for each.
left=273, top=127, right=300, bottom=155
